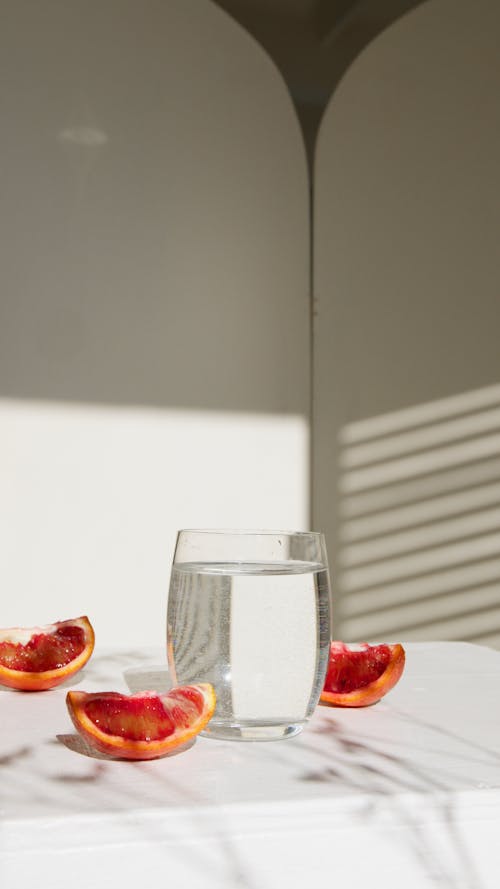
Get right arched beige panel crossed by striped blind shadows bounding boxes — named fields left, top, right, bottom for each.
left=313, top=0, right=500, bottom=645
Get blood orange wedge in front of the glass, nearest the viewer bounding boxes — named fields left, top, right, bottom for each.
left=66, top=683, right=215, bottom=759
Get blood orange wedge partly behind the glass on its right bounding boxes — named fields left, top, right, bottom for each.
left=320, top=642, right=405, bottom=707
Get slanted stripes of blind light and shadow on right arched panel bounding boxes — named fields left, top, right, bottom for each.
left=337, top=384, right=500, bottom=646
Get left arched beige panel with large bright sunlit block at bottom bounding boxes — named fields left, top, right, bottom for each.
left=0, top=0, right=310, bottom=644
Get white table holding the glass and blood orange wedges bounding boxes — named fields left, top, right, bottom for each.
left=0, top=643, right=500, bottom=889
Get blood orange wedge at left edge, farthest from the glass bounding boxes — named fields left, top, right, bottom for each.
left=0, top=617, right=94, bottom=691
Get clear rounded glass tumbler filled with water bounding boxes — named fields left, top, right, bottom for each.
left=167, top=530, right=330, bottom=741
